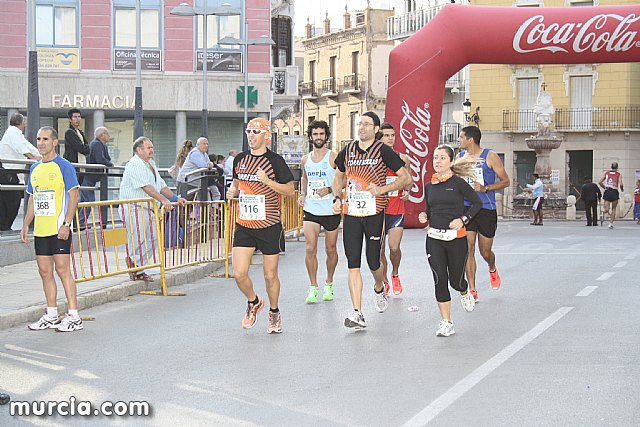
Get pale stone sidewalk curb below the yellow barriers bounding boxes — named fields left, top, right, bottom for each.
left=0, top=261, right=224, bottom=330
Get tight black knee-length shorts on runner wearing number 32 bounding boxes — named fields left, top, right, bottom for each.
left=342, top=211, right=384, bottom=271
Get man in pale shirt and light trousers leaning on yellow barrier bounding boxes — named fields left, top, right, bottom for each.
left=118, top=136, right=186, bottom=281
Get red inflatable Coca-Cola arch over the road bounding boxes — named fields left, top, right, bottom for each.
left=385, top=4, right=640, bottom=227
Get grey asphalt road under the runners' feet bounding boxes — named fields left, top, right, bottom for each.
left=0, top=222, right=640, bottom=426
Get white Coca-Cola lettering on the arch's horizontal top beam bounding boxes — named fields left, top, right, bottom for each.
left=513, top=13, right=640, bottom=53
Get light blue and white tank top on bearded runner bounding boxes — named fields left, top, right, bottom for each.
left=304, top=150, right=336, bottom=216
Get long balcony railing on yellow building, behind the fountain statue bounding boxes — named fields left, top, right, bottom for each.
left=502, top=106, right=640, bottom=132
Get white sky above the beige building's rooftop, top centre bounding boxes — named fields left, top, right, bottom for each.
left=294, top=0, right=394, bottom=36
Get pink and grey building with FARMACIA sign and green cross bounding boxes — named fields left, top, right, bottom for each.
left=0, top=0, right=272, bottom=167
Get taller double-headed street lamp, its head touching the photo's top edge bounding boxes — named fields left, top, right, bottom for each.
left=170, top=0, right=241, bottom=138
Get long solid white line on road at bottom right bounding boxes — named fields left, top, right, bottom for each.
left=403, top=307, right=573, bottom=427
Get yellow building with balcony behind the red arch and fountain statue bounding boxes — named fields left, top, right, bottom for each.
left=468, top=0, right=640, bottom=213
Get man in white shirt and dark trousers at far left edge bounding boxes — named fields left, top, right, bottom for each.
left=0, top=113, right=42, bottom=231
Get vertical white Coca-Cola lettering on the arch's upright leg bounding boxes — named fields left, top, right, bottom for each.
left=400, top=99, right=431, bottom=203
